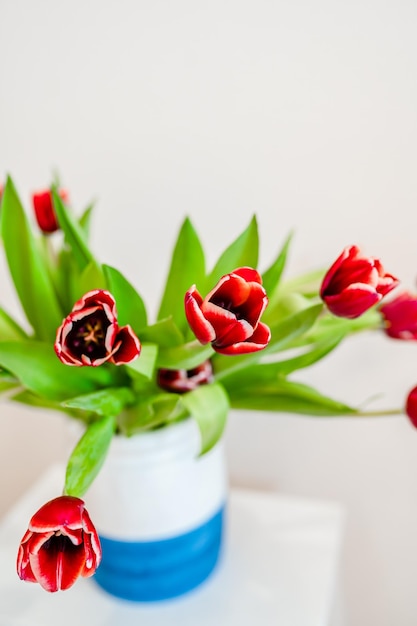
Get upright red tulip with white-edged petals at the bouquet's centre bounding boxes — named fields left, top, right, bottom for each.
left=185, top=267, right=271, bottom=354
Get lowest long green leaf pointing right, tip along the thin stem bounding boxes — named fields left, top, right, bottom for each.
left=229, top=379, right=357, bottom=417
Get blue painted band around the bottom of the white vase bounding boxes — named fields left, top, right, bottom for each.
left=94, top=507, right=224, bottom=602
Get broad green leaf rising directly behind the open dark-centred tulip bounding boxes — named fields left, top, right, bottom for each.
left=103, top=265, right=146, bottom=334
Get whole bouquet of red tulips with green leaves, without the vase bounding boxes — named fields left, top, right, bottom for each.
left=0, top=178, right=417, bottom=591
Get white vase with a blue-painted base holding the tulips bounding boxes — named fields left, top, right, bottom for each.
left=85, top=419, right=227, bottom=601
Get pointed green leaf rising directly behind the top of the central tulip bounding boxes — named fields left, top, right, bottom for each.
left=204, top=216, right=259, bottom=286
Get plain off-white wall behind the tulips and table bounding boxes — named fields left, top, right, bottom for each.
left=0, top=0, right=417, bottom=626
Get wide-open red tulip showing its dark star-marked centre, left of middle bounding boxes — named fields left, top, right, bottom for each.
left=55, top=289, right=141, bottom=366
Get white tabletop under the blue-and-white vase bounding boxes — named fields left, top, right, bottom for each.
left=0, top=467, right=344, bottom=626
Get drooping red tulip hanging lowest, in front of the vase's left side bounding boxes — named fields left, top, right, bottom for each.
left=17, top=496, right=101, bottom=592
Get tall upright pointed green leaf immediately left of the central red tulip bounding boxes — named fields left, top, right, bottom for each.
left=158, top=218, right=205, bottom=332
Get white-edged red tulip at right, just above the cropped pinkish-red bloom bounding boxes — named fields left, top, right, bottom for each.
left=320, top=246, right=399, bottom=319
